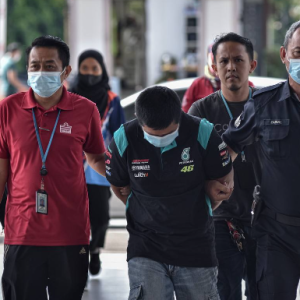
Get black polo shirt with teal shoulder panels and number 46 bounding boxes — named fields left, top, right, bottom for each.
left=106, top=113, right=232, bottom=267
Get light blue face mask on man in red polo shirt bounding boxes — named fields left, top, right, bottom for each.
left=27, top=69, right=65, bottom=98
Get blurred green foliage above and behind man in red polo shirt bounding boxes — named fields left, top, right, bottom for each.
left=7, top=0, right=67, bottom=71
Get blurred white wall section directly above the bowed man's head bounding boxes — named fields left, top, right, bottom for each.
left=146, top=0, right=191, bottom=85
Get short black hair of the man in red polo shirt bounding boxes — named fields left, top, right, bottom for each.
left=26, top=35, right=70, bottom=69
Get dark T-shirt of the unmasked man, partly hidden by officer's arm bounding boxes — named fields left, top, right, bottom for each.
left=189, top=88, right=261, bottom=226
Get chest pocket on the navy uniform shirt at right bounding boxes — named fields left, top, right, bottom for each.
left=262, top=119, right=290, bottom=160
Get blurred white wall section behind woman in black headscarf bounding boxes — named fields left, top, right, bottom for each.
left=68, top=0, right=112, bottom=73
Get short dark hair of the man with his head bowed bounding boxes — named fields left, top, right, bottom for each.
left=135, top=86, right=181, bottom=130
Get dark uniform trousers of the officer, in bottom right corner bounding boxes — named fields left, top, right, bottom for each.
left=256, top=234, right=300, bottom=300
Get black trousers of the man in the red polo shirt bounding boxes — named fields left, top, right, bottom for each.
left=2, top=245, right=89, bottom=300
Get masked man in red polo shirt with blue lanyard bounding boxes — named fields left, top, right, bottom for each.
left=0, top=36, right=105, bottom=300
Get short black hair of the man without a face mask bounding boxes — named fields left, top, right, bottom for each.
left=212, top=32, right=254, bottom=62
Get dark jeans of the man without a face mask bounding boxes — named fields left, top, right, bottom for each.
left=215, top=221, right=258, bottom=300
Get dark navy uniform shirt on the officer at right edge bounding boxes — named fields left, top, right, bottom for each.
left=223, top=81, right=300, bottom=253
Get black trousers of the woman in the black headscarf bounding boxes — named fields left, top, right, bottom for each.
left=87, top=184, right=111, bottom=251
